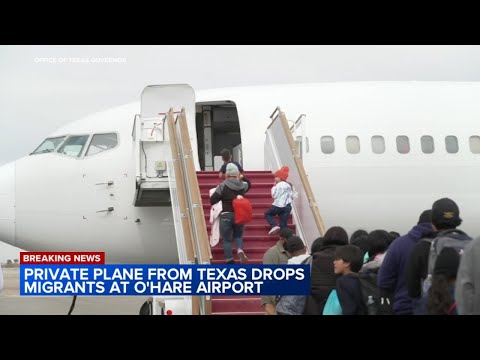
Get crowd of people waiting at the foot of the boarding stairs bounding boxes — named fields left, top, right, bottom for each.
left=262, top=198, right=480, bottom=315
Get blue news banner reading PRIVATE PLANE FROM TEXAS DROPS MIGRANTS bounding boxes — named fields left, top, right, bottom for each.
left=20, top=264, right=310, bottom=296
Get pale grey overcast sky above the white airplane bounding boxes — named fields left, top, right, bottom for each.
left=0, top=45, right=480, bottom=261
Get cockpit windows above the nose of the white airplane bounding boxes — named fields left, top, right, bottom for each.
left=32, top=133, right=118, bottom=157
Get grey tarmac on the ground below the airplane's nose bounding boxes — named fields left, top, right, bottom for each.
left=0, top=266, right=147, bottom=315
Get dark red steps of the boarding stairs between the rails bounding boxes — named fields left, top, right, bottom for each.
left=197, top=171, right=295, bottom=315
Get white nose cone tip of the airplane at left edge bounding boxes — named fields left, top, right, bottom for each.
left=0, top=162, right=15, bottom=246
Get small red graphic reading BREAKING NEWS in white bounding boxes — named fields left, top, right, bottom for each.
left=20, top=251, right=105, bottom=265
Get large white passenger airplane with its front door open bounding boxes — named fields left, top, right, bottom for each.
left=0, top=82, right=480, bottom=263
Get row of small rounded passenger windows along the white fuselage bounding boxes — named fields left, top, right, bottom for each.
left=320, top=135, right=480, bottom=154
